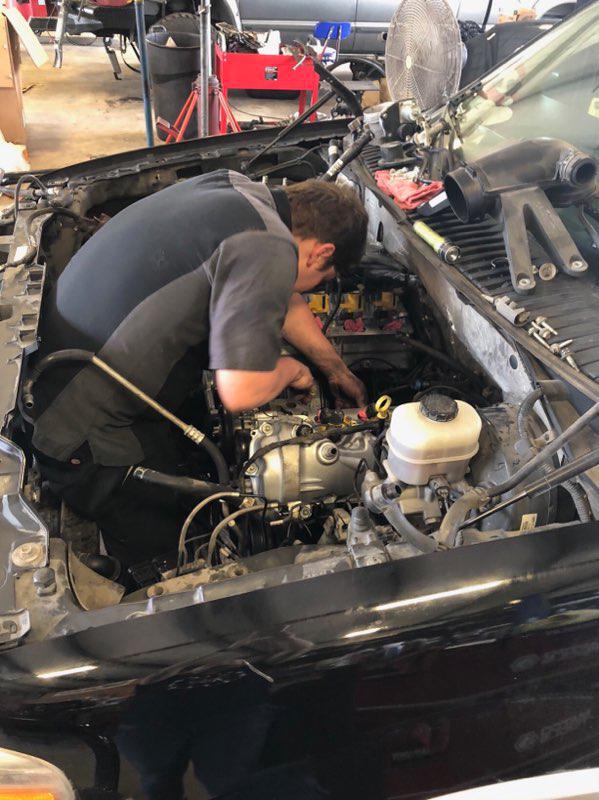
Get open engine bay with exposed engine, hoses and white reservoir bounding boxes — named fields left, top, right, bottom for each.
left=22, top=231, right=564, bottom=603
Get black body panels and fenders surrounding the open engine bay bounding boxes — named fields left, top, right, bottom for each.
left=0, top=6, right=599, bottom=800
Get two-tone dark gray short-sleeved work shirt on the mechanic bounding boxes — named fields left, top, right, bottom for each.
left=33, top=170, right=297, bottom=467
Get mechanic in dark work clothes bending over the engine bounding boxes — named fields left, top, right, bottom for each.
left=32, top=170, right=367, bottom=564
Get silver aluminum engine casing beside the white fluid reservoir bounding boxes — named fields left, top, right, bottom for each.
left=249, top=412, right=374, bottom=503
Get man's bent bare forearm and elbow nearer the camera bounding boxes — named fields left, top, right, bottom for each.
left=216, top=356, right=314, bottom=413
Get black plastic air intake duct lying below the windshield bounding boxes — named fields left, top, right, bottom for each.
left=445, top=138, right=598, bottom=294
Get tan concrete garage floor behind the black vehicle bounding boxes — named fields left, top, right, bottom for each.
left=21, top=42, right=304, bottom=170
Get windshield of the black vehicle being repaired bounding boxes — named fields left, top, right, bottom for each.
left=456, top=2, right=599, bottom=161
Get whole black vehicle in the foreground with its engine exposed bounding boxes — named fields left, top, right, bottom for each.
left=0, top=3, right=599, bottom=800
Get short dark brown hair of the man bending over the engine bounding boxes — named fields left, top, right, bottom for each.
left=285, top=180, right=368, bottom=274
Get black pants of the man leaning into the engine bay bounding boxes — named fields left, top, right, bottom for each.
left=36, top=426, right=186, bottom=566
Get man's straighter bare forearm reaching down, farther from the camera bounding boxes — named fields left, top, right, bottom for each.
left=283, top=293, right=368, bottom=406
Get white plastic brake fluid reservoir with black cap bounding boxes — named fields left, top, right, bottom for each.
left=387, top=394, right=482, bottom=486
